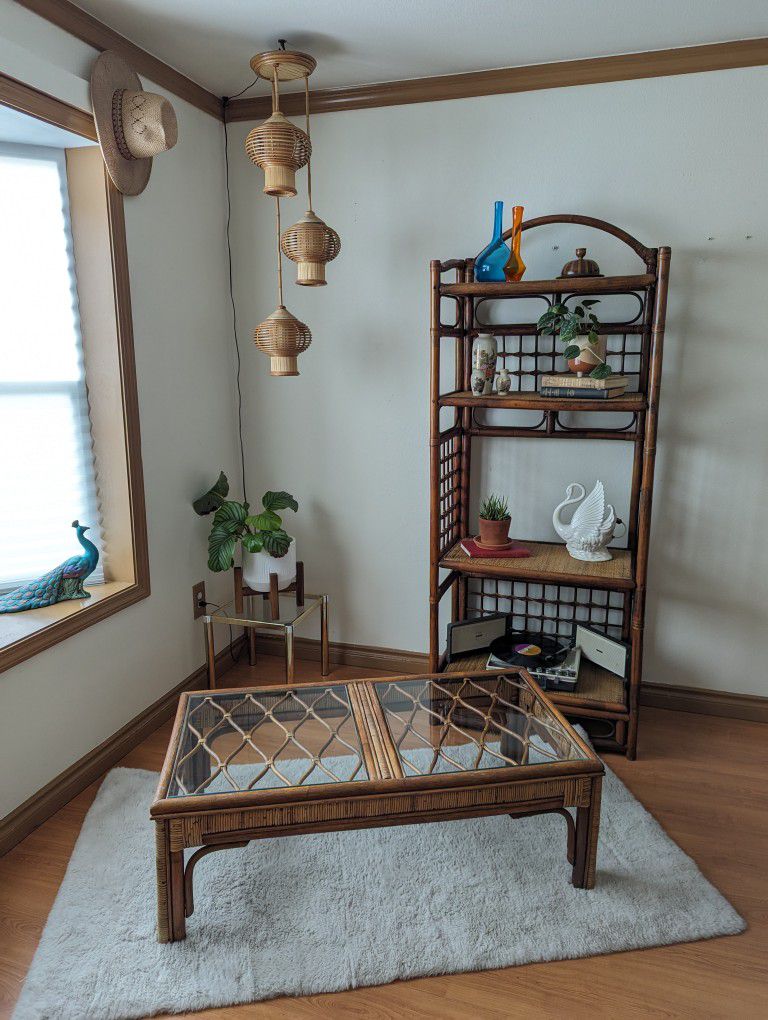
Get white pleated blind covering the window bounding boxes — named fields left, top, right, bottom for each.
left=0, top=143, right=104, bottom=591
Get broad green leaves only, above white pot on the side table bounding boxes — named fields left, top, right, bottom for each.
left=192, top=471, right=299, bottom=572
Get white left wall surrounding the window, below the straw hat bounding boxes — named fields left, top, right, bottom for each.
left=0, top=0, right=237, bottom=817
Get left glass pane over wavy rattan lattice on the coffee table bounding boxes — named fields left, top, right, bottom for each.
left=166, top=684, right=368, bottom=798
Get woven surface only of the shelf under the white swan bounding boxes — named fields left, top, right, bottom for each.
left=442, top=542, right=632, bottom=585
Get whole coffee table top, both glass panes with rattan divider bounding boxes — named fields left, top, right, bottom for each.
left=164, top=672, right=595, bottom=799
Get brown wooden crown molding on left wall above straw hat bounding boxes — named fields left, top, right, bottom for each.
left=16, top=0, right=222, bottom=118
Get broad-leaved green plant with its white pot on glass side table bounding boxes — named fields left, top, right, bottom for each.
left=192, top=471, right=299, bottom=592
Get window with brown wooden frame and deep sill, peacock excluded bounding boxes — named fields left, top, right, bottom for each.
left=0, top=71, right=150, bottom=672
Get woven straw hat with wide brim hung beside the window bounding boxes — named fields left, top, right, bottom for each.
left=91, top=50, right=178, bottom=195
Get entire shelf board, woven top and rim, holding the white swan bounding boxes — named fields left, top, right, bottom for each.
left=440, top=540, right=634, bottom=591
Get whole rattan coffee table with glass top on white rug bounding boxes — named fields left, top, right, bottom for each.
left=150, top=670, right=604, bottom=942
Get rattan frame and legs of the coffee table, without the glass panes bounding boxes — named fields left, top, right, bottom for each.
left=150, top=669, right=605, bottom=942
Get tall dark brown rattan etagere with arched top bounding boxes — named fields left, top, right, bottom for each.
left=429, top=214, right=670, bottom=757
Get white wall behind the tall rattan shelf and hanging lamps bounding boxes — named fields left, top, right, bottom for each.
left=231, top=67, right=768, bottom=695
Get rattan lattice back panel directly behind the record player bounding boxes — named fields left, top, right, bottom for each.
left=467, top=577, right=631, bottom=641
